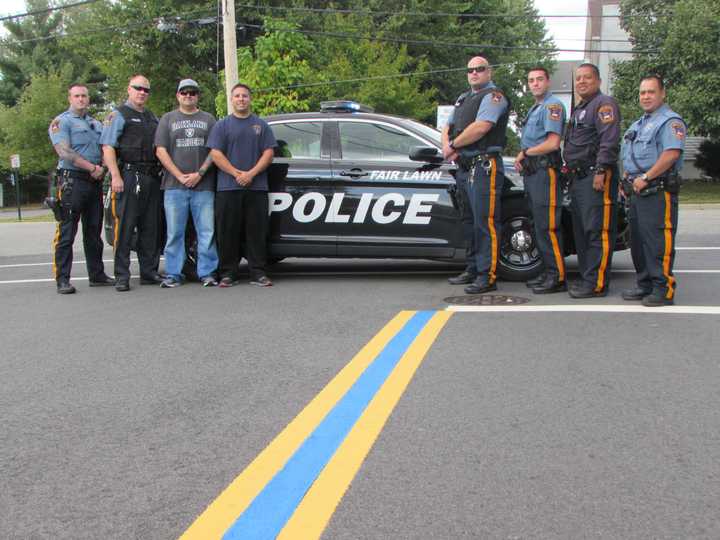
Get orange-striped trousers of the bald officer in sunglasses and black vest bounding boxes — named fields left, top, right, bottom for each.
left=469, top=157, right=505, bottom=284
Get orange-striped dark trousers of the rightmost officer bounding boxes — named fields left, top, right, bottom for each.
left=628, top=191, right=678, bottom=300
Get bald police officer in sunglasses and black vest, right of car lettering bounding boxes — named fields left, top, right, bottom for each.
left=442, top=56, right=510, bottom=294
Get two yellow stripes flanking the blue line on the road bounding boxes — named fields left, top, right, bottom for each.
left=181, top=311, right=452, bottom=540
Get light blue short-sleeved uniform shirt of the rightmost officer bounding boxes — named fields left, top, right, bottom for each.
left=622, top=104, right=687, bottom=175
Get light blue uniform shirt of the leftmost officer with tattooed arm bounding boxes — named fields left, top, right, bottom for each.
left=48, top=109, right=102, bottom=171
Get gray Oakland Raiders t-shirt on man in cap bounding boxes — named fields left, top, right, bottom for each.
left=155, top=110, right=215, bottom=191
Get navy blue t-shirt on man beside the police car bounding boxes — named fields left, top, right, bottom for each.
left=207, top=114, right=277, bottom=191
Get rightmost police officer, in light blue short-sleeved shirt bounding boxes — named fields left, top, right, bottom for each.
left=622, top=75, right=687, bottom=307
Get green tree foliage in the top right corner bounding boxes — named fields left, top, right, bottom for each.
left=613, top=0, right=720, bottom=138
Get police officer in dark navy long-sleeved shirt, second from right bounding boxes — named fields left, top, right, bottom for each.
left=563, top=64, right=620, bottom=298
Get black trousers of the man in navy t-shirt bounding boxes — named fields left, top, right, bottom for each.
left=215, top=189, right=269, bottom=280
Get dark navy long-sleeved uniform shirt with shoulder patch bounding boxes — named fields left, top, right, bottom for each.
left=563, top=92, right=620, bottom=166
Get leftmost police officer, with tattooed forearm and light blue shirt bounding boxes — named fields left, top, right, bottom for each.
left=48, top=83, right=115, bottom=294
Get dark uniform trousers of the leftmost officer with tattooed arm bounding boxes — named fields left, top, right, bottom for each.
left=53, top=176, right=105, bottom=282
